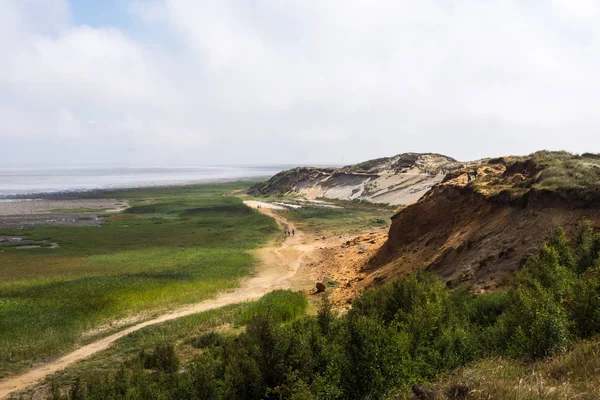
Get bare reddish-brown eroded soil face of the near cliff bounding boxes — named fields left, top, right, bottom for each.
left=364, top=170, right=600, bottom=292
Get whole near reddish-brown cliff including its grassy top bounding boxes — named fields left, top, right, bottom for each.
left=357, top=152, right=600, bottom=291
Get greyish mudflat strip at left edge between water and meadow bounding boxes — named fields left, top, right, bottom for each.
left=0, top=199, right=128, bottom=229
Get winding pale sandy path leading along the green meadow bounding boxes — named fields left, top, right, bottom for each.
left=0, top=202, right=315, bottom=399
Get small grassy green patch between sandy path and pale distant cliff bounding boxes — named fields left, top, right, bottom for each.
left=281, top=199, right=394, bottom=235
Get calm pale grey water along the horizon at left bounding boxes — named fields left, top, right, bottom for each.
left=0, top=166, right=285, bottom=199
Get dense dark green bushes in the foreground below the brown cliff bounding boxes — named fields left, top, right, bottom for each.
left=47, top=222, right=600, bottom=399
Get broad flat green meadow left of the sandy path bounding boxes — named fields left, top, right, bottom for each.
left=0, top=182, right=279, bottom=378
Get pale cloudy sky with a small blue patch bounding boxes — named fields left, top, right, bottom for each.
left=0, top=0, right=600, bottom=167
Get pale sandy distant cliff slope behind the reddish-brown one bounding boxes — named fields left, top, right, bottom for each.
left=249, top=153, right=464, bottom=205
